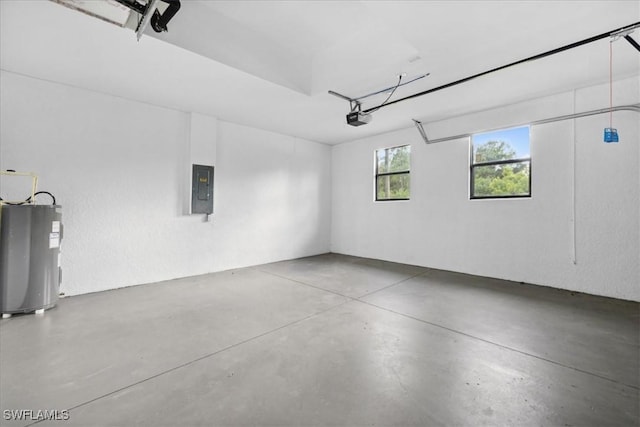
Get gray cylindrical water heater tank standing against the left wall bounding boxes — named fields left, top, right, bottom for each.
left=0, top=205, right=62, bottom=314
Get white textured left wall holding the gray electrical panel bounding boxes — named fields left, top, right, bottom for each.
left=0, top=71, right=331, bottom=295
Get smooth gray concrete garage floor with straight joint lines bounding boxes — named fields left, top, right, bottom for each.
left=0, top=255, right=640, bottom=427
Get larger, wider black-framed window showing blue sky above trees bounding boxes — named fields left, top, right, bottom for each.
left=470, top=126, right=531, bottom=199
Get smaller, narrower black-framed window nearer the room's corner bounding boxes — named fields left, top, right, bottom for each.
left=376, top=145, right=411, bottom=201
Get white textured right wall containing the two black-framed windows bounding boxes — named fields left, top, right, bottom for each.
left=331, top=77, right=640, bottom=300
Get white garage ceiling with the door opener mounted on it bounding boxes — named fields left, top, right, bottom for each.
left=0, top=0, right=640, bottom=144
